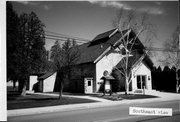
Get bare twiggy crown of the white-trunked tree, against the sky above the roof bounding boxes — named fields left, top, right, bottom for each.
left=112, top=9, right=157, bottom=47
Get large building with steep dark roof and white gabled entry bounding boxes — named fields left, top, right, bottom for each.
left=69, top=29, right=153, bottom=93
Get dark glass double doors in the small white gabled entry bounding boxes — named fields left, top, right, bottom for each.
left=137, top=75, right=146, bottom=89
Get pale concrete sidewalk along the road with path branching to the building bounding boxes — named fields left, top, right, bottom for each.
left=7, top=91, right=180, bottom=117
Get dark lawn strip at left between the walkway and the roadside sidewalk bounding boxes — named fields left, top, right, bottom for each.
left=7, top=92, right=97, bottom=110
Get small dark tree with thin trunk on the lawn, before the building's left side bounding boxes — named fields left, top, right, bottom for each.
left=51, top=40, right=80, bottom=99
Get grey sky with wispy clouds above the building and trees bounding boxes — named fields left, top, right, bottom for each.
left=10, top=1, right=179, bottom=66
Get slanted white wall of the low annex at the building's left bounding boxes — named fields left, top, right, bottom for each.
left=43, top=73, right=57, bottom=92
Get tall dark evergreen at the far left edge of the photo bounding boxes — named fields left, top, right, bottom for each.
left=6, top=2, right=19, bottom=87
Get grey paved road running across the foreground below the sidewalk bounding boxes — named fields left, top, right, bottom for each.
left=8, top=100, right=180, bottom=122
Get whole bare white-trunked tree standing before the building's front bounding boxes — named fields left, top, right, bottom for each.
left=113, top=10, right=155, bottom=93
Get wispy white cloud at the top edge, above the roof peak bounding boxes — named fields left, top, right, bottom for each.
left=89, top=1, right=131, bottom=10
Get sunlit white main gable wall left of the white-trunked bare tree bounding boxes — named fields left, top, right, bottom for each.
left=96, top=50, right=122, bottom=91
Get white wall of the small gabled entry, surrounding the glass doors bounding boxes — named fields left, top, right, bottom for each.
left=132, top=63, right=152, bottom=90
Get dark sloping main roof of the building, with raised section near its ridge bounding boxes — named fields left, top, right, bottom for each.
left=77, top=29, right=128, bottom=64
